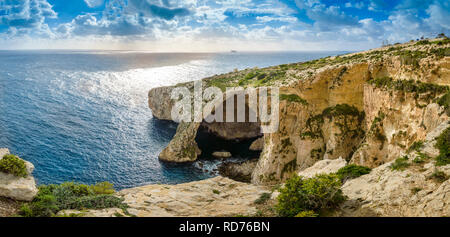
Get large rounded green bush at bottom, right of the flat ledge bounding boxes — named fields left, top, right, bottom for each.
left=276, top=174, right=345, bottom=217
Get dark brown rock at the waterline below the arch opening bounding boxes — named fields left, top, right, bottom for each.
left=219, top=159, right=258, bottom=183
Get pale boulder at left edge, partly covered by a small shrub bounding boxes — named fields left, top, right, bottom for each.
left=0, top=149, right=38, bottom=201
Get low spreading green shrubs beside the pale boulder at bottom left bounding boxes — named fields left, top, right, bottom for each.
left=19, top=182, right=127, bottom=217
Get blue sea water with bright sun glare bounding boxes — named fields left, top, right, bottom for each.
left=0, top=51, right=341, bottom=189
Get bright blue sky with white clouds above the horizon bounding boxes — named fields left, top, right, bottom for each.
left=0, top=0, right=450, bottom=52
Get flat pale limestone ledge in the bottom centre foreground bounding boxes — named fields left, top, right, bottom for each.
left=61, top=177, right=270, bottom=217
